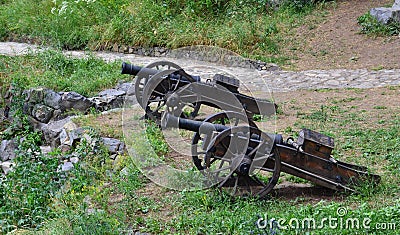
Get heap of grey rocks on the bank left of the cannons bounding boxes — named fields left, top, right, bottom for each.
left=0, top=83, right=132, bottom=174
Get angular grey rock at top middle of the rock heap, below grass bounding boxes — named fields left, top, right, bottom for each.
left=60, top=91, right=93, bottom=112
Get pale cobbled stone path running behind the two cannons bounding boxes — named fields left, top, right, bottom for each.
left=0, top=42, right=400, bottom=92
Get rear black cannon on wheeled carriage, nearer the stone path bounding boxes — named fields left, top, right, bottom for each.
left=121, top=61, right=275, bottom=121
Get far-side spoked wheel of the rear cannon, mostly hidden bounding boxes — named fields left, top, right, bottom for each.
left=135, top=61, right=181, bottom=108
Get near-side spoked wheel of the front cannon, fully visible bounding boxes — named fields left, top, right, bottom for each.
left=203, top=126, right=281, bottom=198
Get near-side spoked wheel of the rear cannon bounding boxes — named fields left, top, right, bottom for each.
left=142, top=69, right=200, bottom=122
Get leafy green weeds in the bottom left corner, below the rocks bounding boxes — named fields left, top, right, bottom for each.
left=0, top=132, right=63, bottom=232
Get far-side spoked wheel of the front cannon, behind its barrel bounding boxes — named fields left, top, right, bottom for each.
left=192, top=111, right=257, bottom=171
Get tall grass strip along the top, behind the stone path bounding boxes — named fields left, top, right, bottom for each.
left=0, top=0, right=332, bottom=64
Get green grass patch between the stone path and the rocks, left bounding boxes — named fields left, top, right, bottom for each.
left=0, top=50, right=128, bottom=96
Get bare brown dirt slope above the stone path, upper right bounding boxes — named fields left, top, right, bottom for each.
left=288, top=0, right=400, bottom=70
